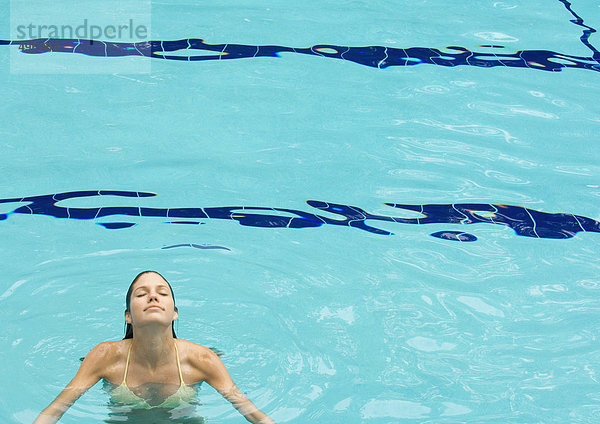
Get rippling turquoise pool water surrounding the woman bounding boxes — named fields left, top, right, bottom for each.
left=0, top=1, right=600, bottom=424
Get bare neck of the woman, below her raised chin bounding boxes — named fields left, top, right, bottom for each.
left=131, top=326, right=175, bottom=369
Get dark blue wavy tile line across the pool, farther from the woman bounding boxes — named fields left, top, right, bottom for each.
left=0, top=38, right=600, bottom=72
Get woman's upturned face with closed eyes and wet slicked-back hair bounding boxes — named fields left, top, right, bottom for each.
left=125, top=272, right=178, bottom=328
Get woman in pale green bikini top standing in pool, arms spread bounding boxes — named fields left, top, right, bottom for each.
left=34, top=271, right=274, bottom=424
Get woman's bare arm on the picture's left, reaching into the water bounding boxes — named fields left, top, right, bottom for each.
left=33, top=343, right=109, bottom=424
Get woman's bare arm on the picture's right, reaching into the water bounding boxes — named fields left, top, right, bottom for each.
left=203, top=351, right=275, bottom=424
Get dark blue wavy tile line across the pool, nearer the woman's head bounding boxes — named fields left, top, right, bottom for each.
left=0, top=190, right=600, bottom=242
